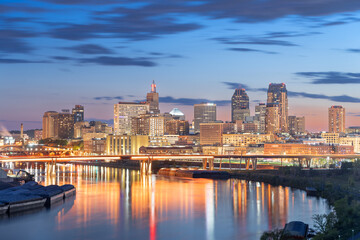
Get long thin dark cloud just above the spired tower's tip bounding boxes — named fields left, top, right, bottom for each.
left=78, top=56, right=157, bottom=67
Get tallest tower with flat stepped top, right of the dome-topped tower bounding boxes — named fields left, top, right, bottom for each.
left=267, top=83, right=288, bottom=133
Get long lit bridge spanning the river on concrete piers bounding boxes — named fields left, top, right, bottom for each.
left=0, top=154, right=360, bottom=173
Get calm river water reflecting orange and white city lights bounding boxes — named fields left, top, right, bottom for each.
left=0, top=164, right=329, bottom=240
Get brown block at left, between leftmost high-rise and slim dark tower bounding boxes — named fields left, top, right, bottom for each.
left=54, top=110, right=74, bottom=139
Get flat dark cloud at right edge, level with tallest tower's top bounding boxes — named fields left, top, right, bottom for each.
left=296, top=72, right=360, bottom=84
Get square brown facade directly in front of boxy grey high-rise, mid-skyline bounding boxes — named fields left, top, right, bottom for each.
left=200, top=123, right=223, bottom=145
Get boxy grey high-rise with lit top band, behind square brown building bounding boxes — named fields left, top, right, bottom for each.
left=194, top=103, right=216, bottom=133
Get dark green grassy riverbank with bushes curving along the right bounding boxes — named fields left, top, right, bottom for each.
left=229, top=166, right=360, bottom=240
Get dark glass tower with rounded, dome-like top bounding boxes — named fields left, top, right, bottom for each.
left=231, top=88, right=250, bottom=122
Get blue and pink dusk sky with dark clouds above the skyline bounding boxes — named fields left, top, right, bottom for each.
left=0, top=0, right=360, bottom=131
